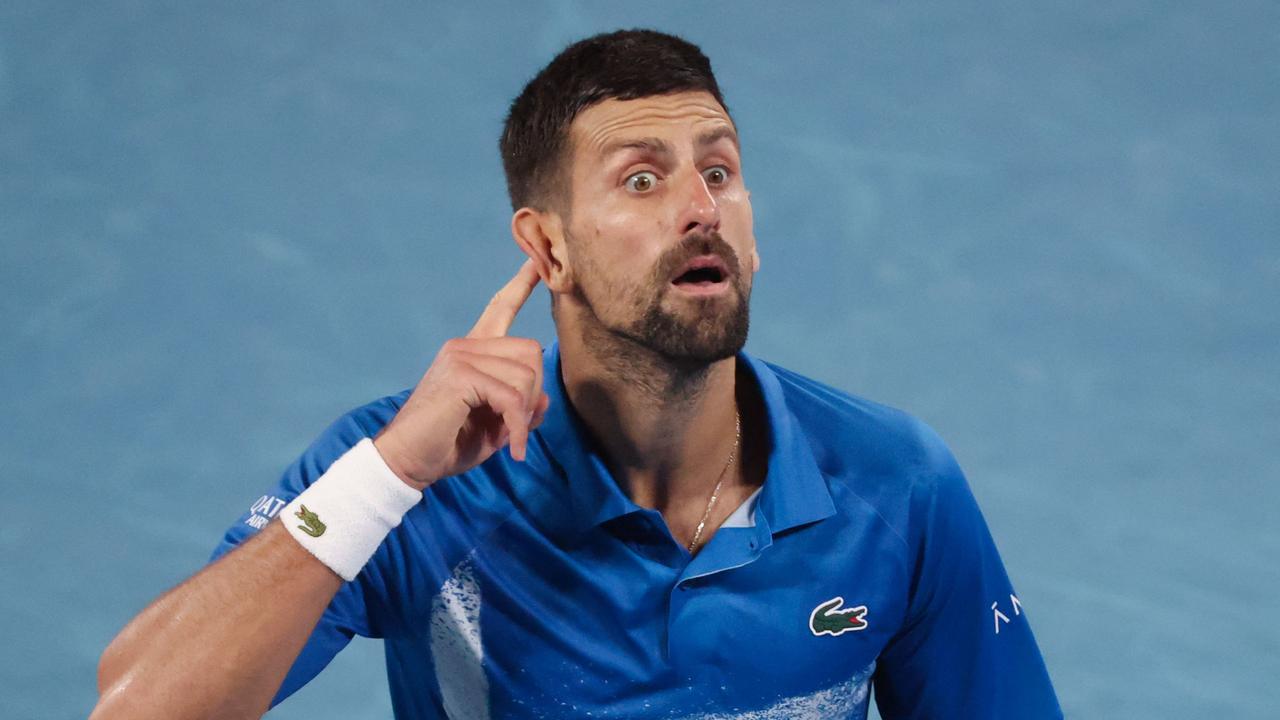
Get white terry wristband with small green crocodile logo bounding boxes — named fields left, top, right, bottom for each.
left=280, top=438, right=422, bottom=580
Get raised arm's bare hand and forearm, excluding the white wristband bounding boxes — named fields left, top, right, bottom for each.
left=92, top=261, right=548, bottom=720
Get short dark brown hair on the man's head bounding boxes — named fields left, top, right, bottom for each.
left=498, top=29, right=728, bottom=211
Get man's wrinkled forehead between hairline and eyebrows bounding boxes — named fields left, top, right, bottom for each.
left=570, top=92, right=737, bottom=155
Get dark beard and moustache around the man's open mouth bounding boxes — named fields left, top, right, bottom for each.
left=576, top=233, right=750, bottom=363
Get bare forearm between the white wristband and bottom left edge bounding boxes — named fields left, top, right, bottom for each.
left=92, top=520, right=343, bottom=720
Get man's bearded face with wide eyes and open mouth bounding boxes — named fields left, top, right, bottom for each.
left=564, top=92, right=758, bottom=363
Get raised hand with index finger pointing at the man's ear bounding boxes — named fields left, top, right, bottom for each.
left=374, top=260, right=550, bottom=489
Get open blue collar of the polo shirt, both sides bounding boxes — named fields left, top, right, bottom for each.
left=532, top=342, right=836, bottom=536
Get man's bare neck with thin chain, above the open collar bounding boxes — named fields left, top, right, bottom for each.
left=559, top=317, right=746, bottom=509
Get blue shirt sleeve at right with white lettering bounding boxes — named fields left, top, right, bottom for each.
left=874, top=427, right=1062, bottom=720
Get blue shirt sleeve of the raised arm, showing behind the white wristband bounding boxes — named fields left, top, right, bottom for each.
left=210, top=398, right=398, bottom=707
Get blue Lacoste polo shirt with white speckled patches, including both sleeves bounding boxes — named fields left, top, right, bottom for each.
left=214, top=343, right=1061, bottom=720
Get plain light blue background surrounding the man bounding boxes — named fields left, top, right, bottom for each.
left=0, top=1, right=1280, bottom=719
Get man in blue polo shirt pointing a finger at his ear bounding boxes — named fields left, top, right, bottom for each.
left=95, top=31, right=1061, bottom=719
